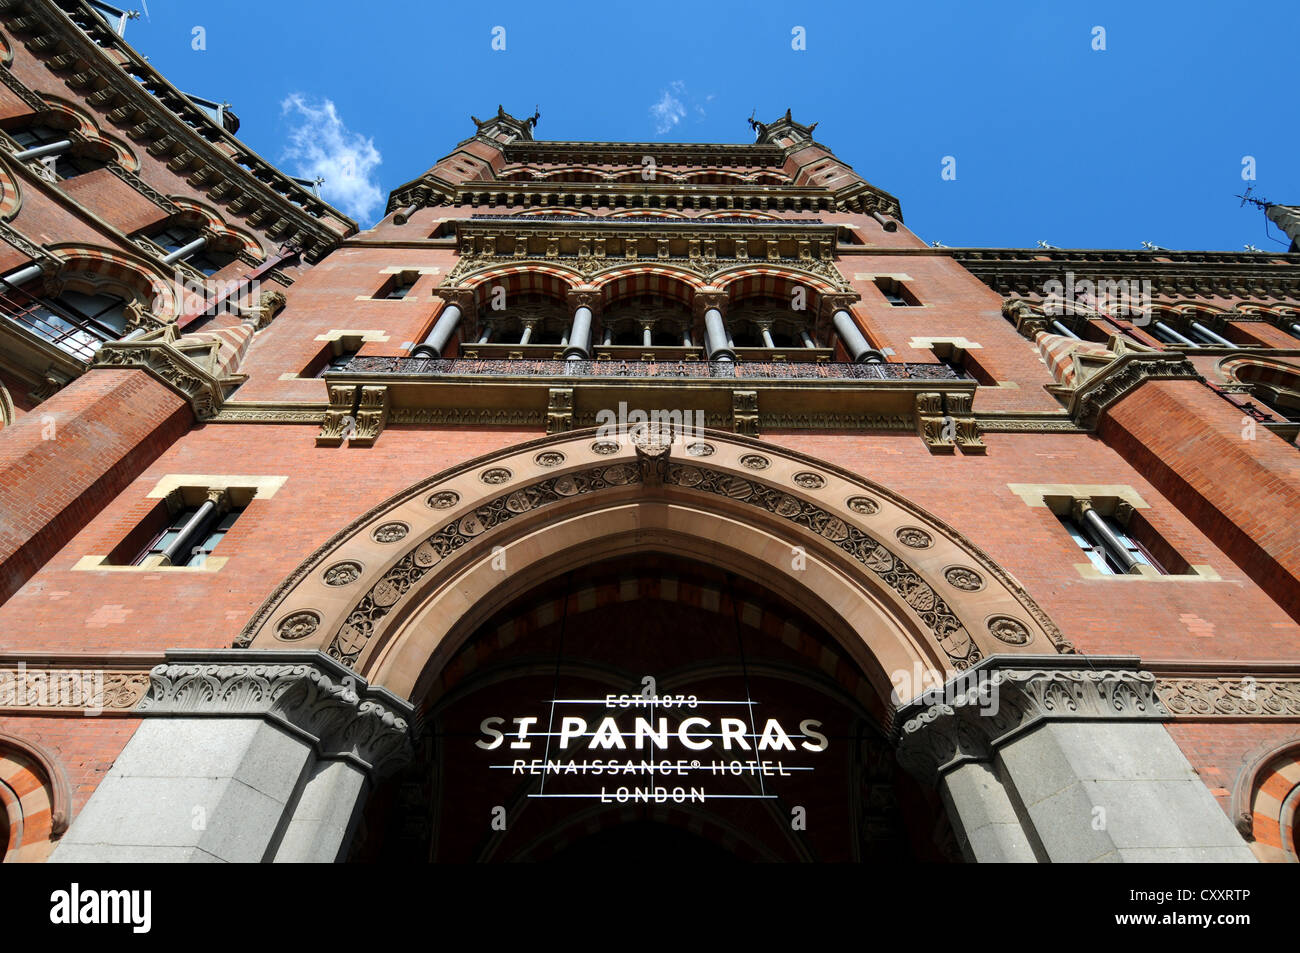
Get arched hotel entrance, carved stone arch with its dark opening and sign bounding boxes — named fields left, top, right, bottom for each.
left=228, top=426, right=1069, bottom=861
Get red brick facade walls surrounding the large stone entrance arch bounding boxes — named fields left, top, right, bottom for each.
left=0, top=1, right=1300, bottom=859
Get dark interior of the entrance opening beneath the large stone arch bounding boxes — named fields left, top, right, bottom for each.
left=351, top=553, right=959, bottom=863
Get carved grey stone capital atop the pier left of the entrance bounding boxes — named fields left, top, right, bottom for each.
left=137, top=649, right=413, bottom=775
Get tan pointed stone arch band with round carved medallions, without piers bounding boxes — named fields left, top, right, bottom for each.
left=237, top=429, right=1073, bottom=698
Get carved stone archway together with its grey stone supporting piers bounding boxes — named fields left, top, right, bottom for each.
left=55, top=425, right=1253, bottom=862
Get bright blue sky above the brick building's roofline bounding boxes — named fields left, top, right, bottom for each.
left=120, top=0, right=1300, bottom=251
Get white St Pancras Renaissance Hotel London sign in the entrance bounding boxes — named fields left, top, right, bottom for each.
left=475, top=694, right=829, bottom=803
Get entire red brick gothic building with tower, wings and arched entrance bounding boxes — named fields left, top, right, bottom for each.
left=0, top=0, right=1300, bottom=862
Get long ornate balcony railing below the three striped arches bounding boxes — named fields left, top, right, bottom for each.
left=330, top=358, right=974, bottom=384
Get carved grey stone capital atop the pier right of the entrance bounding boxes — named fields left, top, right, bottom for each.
left=894, top=655, right=1170, bottom=784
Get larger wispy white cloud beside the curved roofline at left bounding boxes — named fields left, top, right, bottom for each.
left=280, top=92, right=384, bottom=225
